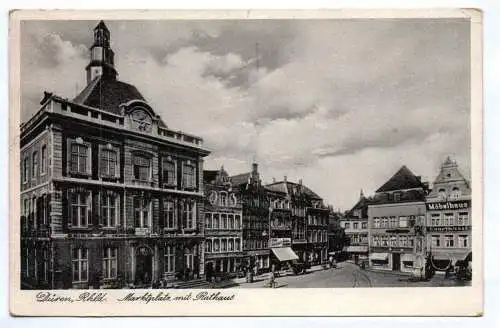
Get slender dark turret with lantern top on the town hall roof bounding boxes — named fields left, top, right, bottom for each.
left=85, top=21, right=118, bottom=84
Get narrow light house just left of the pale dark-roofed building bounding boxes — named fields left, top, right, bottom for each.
left=340, top=192, right=369, bottom=263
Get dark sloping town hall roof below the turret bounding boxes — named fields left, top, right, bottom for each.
left=73, top=76, right=145, bottom=114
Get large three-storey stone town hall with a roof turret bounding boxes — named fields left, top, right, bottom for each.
left=20, top=21, right=209, bottom=289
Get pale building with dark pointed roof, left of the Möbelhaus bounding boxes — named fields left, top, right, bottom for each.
left=368, top=166, right=428, bottom=273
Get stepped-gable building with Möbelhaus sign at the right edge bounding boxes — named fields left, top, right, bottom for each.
left=426, top=157, right=472, bottom=270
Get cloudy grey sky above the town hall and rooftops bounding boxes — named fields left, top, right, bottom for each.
left=21, top=19, right=470, bottom=209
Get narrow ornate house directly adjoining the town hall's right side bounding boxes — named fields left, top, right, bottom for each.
left=204, top=168, right=245, bottom=280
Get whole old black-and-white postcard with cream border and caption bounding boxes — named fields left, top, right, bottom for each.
left=9, top=9, right=483, bottom=316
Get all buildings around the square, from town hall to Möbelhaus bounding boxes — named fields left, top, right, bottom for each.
left=20, top=21, right=472, bottom=289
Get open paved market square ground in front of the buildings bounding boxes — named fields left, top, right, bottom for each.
left=229, top=263, right=470, bottom=288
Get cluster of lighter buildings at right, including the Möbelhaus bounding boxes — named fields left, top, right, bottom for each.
left=340, top=158, right=472, bottom=275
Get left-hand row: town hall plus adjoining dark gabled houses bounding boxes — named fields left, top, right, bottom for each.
left=19, top=22, right=330, bottom=289
